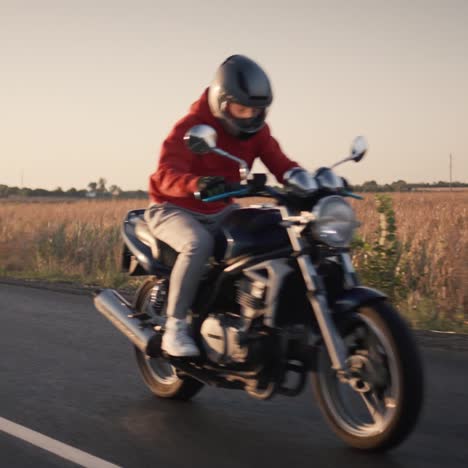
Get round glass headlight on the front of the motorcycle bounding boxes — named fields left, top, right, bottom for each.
left=312, top=195, right=359, bottom=247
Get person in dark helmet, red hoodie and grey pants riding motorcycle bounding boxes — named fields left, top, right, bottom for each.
left=145, top=55, right=303, bottom=357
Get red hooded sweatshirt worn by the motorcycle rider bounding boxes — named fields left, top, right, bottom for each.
left=149, top=90, right=298, bottom=214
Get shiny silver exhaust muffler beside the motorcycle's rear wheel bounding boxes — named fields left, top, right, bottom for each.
left=94, top=289, right=161, bottom=357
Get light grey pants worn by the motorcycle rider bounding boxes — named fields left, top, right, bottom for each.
left=145, top=202, right=239, bottom=319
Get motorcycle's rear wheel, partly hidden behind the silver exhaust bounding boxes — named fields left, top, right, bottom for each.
left=134, top=279, right=203, bottom=400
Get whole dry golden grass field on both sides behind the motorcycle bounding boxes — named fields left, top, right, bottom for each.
left=0, top=191, right=468, bottom=329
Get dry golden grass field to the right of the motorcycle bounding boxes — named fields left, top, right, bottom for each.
left=353, top=191, right=468, bottom=331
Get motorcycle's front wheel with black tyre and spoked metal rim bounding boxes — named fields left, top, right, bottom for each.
left=312, top=301, right=423, bottom=451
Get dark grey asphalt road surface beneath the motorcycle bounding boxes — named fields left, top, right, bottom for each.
left=0, top=284, right=468, bottom=468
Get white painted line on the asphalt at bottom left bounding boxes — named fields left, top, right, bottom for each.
left=0, top=417, right=120, bottom=468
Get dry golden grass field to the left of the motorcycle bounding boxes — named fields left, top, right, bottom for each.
left=0, top=200, right=141, bottom=286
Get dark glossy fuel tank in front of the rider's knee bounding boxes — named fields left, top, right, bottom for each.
left=222, top=208, right=289, bottom=261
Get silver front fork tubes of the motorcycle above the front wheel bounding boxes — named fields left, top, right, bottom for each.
left=279, top=206, right=357, bottom=380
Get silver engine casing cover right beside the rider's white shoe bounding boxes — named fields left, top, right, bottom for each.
left=201, top=315, right=249, bottom=364
